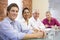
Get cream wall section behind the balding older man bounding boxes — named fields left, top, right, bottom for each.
left=32, top=0, right=49, bottom=19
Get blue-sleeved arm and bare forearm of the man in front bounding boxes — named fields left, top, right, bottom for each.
left=0, top=24, right=43, bottom=39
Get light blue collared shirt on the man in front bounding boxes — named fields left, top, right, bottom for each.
left=0, top=17, right=32, bottom=40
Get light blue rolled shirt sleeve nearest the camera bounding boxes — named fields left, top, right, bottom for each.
left=0, top=23, right=25, bottom=39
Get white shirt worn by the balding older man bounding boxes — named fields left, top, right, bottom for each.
left=29, top=17, right=45, bottom=30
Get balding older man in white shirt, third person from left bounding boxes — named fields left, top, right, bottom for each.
left=29, top=10, right=45, bottom=30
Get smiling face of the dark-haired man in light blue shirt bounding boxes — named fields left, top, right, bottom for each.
left=8, top=7, right=18, bottom=20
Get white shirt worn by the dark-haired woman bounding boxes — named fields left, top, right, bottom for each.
left=20, top=18, right=33, bottom=33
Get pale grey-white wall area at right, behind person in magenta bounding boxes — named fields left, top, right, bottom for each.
left=49, top=0, right=60, bottom=21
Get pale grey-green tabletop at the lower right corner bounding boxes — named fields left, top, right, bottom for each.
left=28, top=29, right=60, bottom=40
